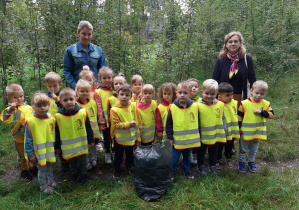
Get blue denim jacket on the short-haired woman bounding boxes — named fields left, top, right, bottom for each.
left=63, top=41, right=106, bottom=88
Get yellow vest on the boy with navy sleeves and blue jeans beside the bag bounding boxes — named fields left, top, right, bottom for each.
left=170, top=103, right=201, bottom=149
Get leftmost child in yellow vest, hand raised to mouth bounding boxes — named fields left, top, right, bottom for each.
left=0, top=84, right=37, bottom=180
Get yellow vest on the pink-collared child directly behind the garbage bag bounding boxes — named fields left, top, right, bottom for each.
left=137, top=100, right=158, bottom=143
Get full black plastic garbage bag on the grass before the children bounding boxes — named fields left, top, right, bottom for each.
left=134, top=141, right=173, bottom=202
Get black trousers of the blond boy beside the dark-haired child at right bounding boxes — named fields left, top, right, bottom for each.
left=197, top=142, right=218, bottom=166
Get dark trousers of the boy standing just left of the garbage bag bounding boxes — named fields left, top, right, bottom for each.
left=114, top=141, right=134, bottom=173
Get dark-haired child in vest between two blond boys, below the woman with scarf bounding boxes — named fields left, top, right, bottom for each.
left=216, top=82, right=240, bottom=169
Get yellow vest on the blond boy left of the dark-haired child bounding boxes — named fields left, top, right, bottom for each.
left=198, top=101, right=226, bottom=145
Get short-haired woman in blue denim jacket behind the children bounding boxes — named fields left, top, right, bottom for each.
left=63, top=20, right=106, bottom=88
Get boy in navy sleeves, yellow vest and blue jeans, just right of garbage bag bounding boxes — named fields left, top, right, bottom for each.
left=166, top=81, right=200, bottom=179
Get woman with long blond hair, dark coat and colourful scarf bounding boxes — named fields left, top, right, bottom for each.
left=213, top=31, right=256, bottom=105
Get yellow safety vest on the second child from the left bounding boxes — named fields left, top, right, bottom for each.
left=25, top=116, right=56, bottom=167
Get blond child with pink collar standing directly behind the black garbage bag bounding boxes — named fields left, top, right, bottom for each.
left=137, top=84, right=158, bottom=146
